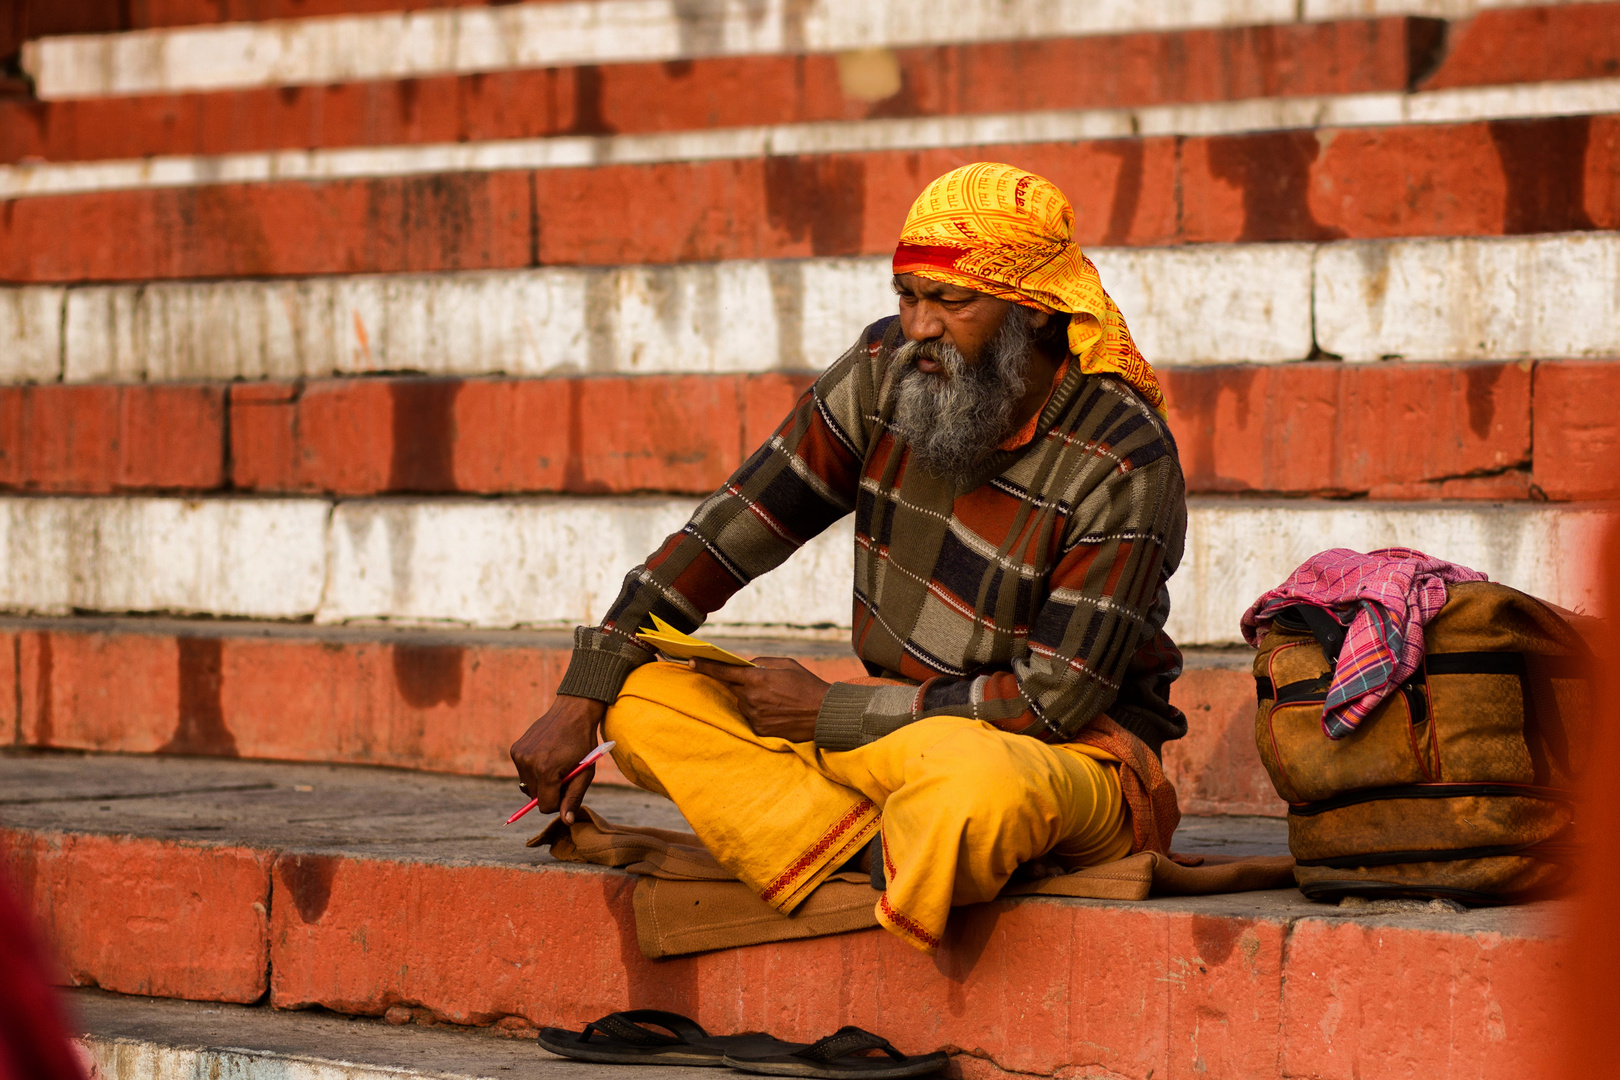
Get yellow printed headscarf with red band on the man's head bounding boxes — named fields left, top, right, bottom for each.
left=894, top=162, right=1166, bottom=416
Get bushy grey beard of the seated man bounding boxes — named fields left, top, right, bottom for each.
left=894, top=304, right=1035, bottom=476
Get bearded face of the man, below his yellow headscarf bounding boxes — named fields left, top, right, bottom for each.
left=894, top=274, right=1043, bottom=476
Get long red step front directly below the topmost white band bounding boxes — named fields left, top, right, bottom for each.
left=0, top=16, right=1445, bottom=162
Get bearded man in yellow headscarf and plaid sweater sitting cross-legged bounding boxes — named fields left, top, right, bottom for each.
left=512, top=162, right=1186, bottom=952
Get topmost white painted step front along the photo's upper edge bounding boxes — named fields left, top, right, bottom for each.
left=23, top=0, right=1600, bottom=99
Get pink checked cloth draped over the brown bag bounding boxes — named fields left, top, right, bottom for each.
left=1243, top=547, right=1489, bottom=738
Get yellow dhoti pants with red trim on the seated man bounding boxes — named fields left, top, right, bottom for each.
left=603, top=662, right=1131, bottom=952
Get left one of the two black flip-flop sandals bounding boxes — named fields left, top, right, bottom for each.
left=539, top=1009, right=794, bottom=1069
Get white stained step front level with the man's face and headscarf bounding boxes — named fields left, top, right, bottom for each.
left=0, top=233, right=1620, bottom=382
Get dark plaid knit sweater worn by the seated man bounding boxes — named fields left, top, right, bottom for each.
left=557, top=316, right=1187, bottom=753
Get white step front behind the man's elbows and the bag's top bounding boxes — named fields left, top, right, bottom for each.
left=0, top=497, right=1614, bottom=646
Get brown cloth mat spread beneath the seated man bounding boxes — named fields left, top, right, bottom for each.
left=528, top=806, right=1294, bottom=960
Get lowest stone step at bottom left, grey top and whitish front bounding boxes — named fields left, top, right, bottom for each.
left=63, top=989, right=695, bottom=1080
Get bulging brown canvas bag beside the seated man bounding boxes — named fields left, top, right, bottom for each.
left=1254, top=581, right=1591, bottom=904
